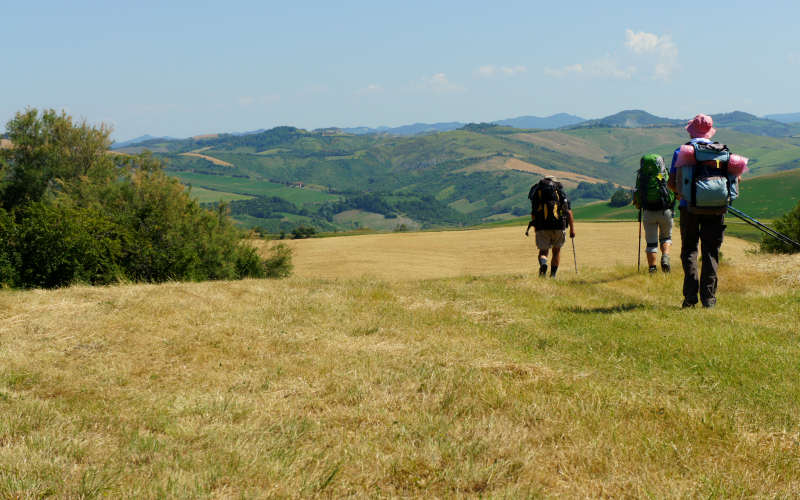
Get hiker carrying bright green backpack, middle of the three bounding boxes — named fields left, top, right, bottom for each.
left=633, top=154, right=675, bottom=274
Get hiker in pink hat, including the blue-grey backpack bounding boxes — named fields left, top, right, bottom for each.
left=668, top=114, right=739, bottom=308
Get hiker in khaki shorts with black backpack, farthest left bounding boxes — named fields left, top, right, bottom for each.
left=525, top=175, right=575, bottom=278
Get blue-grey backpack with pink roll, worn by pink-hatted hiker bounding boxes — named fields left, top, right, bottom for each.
left=676, top=142, right=739, bottom=214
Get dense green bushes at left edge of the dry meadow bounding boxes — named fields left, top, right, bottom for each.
left=0, top=110, right=291, bottom=288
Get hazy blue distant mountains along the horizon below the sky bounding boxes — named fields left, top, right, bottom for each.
left=112, top=109, right=800, bottom=149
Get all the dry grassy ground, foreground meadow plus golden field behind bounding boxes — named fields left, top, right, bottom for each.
left=0, top=224, right=800, bottom=498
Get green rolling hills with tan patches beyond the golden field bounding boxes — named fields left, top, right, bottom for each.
left=114, top=117, right=800, bottom=233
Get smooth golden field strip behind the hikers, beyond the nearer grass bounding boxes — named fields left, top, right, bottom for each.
left=272, top=221, right=755, bottom=280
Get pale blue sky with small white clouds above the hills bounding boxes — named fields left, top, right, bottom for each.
left=0, top=0, right=800, bottom=140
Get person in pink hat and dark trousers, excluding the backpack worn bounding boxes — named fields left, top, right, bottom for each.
left=668, top=114, right=736, bottom=308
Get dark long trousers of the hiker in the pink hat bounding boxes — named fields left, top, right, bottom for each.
left=681, top=207, right=725, bottom=306
